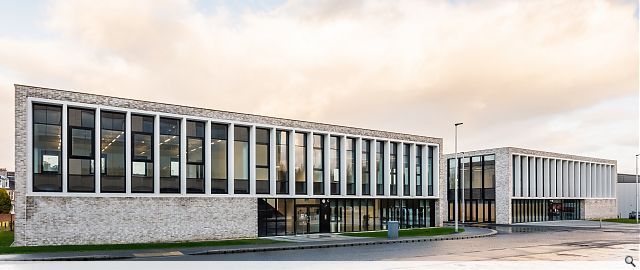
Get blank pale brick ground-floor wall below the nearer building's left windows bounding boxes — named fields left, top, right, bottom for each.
left=22, top=196, right=258, bottom=246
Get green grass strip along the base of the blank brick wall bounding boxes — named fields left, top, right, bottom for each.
left=0, top=231, right=283, bottom=254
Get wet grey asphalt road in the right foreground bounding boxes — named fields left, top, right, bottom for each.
left=131, top=227, right=640, bottom=261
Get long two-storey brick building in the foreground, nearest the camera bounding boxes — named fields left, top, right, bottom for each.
left=14, top=85, right=445, bottom=246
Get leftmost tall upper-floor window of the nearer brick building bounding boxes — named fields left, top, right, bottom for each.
left=33, top=104, right=62, bottom=192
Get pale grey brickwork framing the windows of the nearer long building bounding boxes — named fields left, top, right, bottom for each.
left=13, top=85, right=446, bottom=246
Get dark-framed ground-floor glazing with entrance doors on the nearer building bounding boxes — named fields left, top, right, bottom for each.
left=258, top=198, right=435, bottom=236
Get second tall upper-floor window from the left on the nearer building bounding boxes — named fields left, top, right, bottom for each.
left=67, top=108, right=95, bottom=192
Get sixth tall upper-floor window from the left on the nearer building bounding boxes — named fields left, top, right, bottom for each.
left=187, top=121, right=204, bottom=194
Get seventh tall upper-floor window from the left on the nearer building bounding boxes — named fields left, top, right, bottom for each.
left=211, top=123, right=228, bottom=194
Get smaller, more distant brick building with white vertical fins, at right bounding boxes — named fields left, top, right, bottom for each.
left=443, top=147, right=618, bottom=224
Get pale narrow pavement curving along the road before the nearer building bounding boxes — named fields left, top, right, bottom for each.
left=0, top=227, right=497, bottom=261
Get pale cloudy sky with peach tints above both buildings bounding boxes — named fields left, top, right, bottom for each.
left=0, top=0, right=639, bottom=173
